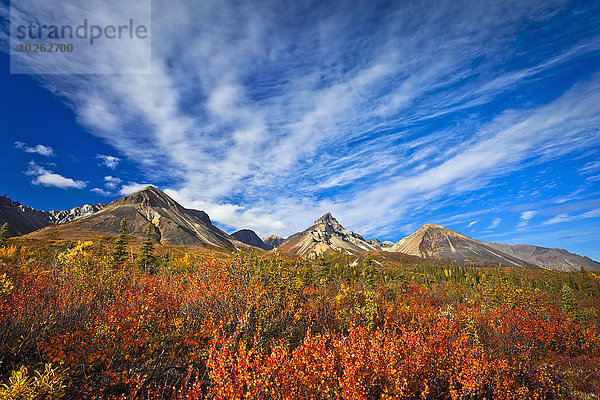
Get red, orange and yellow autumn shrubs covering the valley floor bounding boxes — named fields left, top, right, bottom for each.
left=0, top=222, right=600, bottom=399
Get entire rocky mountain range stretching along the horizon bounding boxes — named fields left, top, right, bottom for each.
left=0, top=186, right=600, bottom=271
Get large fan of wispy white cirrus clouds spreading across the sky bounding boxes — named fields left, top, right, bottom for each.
left=3, top=1, right=600, bottom=241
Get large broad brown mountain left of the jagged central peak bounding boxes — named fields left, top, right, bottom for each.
left=31, top=186, right=237, bottom=250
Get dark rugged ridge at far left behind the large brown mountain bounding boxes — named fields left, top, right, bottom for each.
left=0, top=195, right=105, bottom=236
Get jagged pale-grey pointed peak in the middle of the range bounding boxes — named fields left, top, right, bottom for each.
left=279, top=213, right=376, bottom=258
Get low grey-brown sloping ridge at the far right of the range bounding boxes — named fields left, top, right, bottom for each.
left=484, top=242, right=600, bottom=271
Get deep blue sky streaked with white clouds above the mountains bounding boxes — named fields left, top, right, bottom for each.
left=0, top=0, right=600, bottom=260
